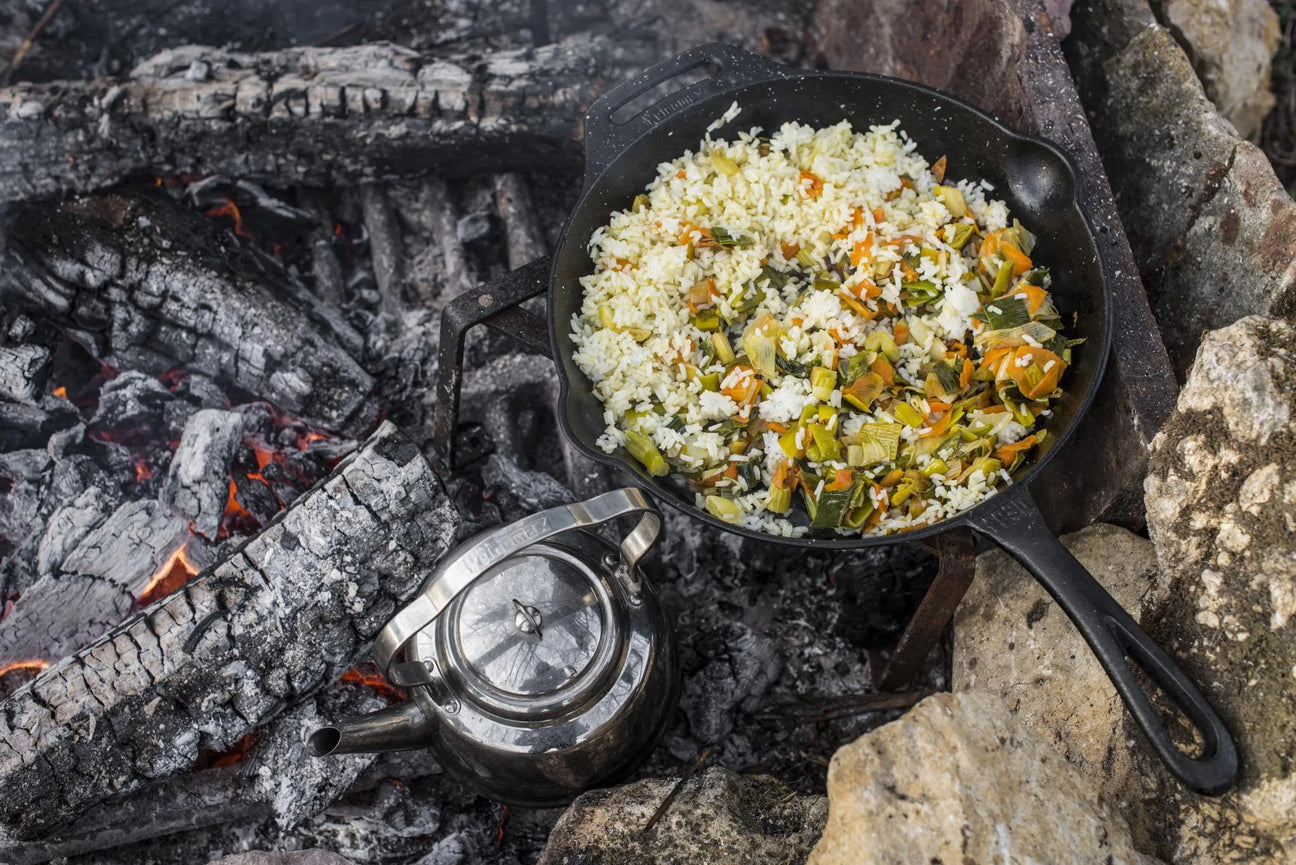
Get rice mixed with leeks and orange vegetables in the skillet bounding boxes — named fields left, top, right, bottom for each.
left=572, top=105, right=1080, bottom=536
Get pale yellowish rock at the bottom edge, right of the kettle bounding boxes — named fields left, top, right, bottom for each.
left=809, top=694, right=1151, bottom=865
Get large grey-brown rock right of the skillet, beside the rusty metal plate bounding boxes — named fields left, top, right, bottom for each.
left=1067, top=0, right=1296, bottom=376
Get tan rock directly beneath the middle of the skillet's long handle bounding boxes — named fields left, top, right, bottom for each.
left=951, top=525, right=1165, bottom=803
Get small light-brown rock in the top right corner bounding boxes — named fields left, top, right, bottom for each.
left=1155, top=0, right=1279, bottom=139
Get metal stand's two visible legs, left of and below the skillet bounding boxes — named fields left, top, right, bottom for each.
left=433, top=258, right=976, bottom=691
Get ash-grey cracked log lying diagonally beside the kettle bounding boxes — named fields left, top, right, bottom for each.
left=0, top=424, right=460, bottom=853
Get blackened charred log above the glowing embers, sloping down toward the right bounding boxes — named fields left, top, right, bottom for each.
left=0, top=195, right=377, bottom=434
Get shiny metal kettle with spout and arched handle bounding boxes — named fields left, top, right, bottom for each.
left=308, top=488, right=679, bottom=807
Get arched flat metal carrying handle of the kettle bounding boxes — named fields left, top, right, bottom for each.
left=373, top=486, right=661, bottom=672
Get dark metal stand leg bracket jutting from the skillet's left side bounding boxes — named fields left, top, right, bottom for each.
left=432, top=255, right=553, bottom=475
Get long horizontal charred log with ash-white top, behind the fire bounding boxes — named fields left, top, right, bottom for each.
left=0, top=35, right=609, bottom=200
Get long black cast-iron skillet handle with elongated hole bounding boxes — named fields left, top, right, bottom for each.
left=968, top=485, right=1238, bottom=796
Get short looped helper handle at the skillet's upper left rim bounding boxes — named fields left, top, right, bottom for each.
left=584, top=41, right=789, bottom=185
